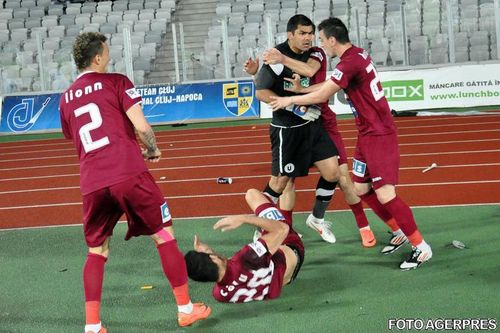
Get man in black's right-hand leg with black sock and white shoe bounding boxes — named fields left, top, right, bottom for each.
left=306, top=156, right=340, bottom=243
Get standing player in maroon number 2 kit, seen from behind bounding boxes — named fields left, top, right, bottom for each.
left=59, top=32, right=211, bottom=333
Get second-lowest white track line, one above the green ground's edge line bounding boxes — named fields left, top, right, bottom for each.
left=0, top=179, right=500, bottom=210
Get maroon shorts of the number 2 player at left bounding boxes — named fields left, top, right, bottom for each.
left=83, top=172, right=172, bottom=247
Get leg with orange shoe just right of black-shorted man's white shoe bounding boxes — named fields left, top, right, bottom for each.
left=339, top=163, right=377, bottom=247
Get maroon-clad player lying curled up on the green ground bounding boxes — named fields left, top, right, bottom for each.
left=185, top=180, right=304, bottom=303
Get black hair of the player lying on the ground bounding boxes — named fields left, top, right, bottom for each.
left=184, top=250, right=219, bottom=282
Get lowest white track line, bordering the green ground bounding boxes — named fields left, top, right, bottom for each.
left=0, top=202, right=500, bottom=234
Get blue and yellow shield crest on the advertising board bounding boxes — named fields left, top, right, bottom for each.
left=222, top=82, right=254, bottom=116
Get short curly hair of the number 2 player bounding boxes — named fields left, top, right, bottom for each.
left=73, top=32, right=108, bottom=70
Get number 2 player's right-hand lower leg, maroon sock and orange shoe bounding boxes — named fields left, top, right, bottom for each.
left=150, top=226, right=211, bottom=326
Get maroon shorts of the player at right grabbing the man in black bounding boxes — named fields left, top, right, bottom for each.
left=352, top=133, right=399, bottom=189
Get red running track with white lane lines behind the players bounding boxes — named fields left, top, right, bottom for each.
left=0, top=115, right=500, bottom=229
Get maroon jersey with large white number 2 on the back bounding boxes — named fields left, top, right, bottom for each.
left=59, top=72, right=147, bottom=195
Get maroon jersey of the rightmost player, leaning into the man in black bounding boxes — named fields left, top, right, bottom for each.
left=331, top=46, right=396, bottom=135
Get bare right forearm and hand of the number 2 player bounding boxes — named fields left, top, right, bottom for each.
left=127, top=104, right=161, bottom=162
